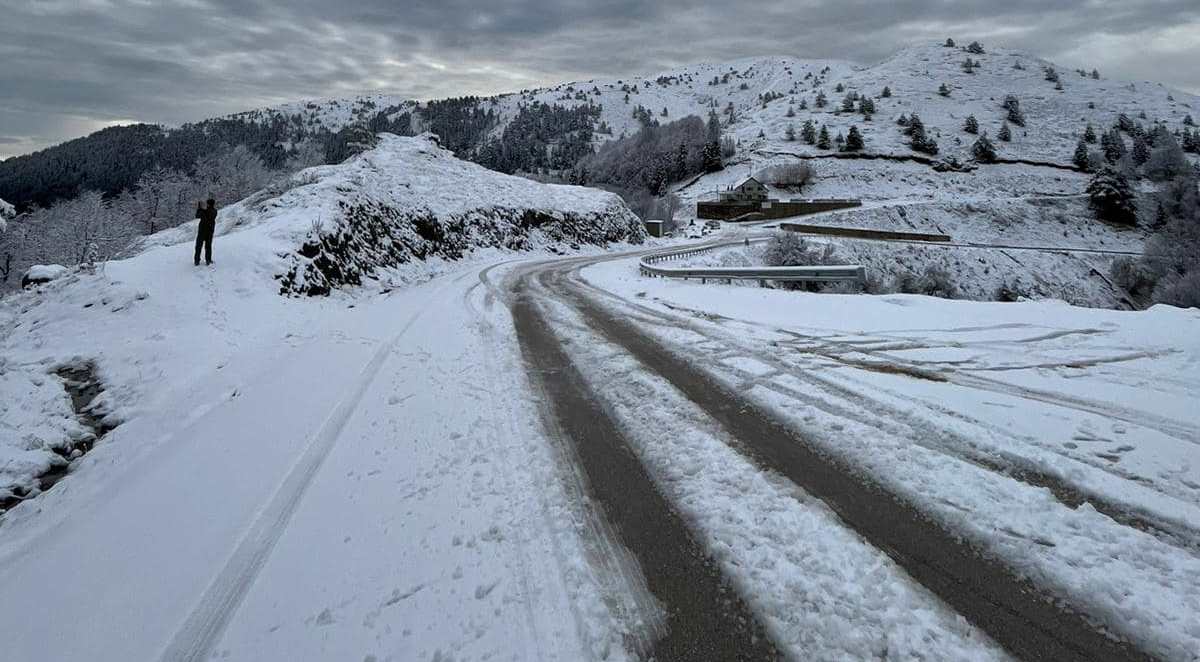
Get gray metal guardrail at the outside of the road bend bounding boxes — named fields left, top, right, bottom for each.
left=637, top=239, right=866, bottom=284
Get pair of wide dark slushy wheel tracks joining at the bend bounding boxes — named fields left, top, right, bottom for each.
left=493, top=247, right=1151, bottom=661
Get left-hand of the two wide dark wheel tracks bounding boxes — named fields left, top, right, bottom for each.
left=509, top=258, right=780, bottom=661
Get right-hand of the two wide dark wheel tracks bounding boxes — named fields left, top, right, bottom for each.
left=539, top=254, right=1148, bottom=661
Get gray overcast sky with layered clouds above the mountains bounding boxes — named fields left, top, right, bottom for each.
left=0, top=0, right=1200, bottom=158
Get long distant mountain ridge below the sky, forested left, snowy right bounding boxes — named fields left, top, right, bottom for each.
left=0, top=43, right=1200, bottom=207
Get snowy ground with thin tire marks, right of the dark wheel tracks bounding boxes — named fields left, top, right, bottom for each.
left=583, top=255, right=1200, bottom=660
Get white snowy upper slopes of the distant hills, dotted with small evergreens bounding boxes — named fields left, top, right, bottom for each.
left=242, top=43, right=1200, bottom=169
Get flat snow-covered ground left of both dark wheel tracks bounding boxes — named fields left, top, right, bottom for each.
left=0, top=251, right=653, bottom=662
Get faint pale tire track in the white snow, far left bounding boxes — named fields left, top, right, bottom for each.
left=158, top=285, right=446, bottom=662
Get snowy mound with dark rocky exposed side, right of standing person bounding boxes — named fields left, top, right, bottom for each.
left=138, top=134, right=646, bottom=295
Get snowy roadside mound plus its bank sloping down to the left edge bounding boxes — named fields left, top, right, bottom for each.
left=0, top=134, right=644, bottom=501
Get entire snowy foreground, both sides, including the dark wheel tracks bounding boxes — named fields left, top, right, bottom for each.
left=0, top=235, right=1200, bottom=661
